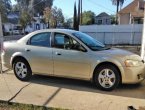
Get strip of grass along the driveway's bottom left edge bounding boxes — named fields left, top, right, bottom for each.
left=0, top=101, right=67, bottom=110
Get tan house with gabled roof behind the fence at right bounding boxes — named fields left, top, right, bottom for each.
left=118, top=0, right=145, bottom=24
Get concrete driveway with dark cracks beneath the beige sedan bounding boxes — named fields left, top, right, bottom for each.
left=0, top=71, right=145, bottom=110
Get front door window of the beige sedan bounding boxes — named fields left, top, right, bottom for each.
left=54, top=33, right=79, bottom=50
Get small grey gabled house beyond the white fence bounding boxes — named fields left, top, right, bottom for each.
left=95, top=12, right=111, bottom=25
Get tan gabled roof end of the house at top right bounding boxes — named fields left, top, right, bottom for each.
left=118, top=0, right=145, bottom=14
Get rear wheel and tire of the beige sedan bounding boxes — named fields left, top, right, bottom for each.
left=13, top=58, right=32, bottom=81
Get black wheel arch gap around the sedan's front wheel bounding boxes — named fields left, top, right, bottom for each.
left=92, top=61, right=122, bottom=83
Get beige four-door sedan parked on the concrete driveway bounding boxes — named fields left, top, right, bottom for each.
left=2, top=29, right=145, bottom=90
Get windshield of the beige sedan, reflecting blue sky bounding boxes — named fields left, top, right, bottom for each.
left=73, top=32, right=106, bottom=51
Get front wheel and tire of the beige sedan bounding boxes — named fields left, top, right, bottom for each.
left=94, top=65, right=121, bottom=91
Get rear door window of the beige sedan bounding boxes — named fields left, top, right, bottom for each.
left=30, top=33, right=51, bottom=47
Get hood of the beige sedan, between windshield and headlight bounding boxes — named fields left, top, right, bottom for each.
left=95, top=48, right=142, bottom=61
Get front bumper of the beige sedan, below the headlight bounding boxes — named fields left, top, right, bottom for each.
left=122, top=64, right=145, bottom=84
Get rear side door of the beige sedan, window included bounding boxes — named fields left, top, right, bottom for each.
left=25, top=32, right=53, bottom=74
